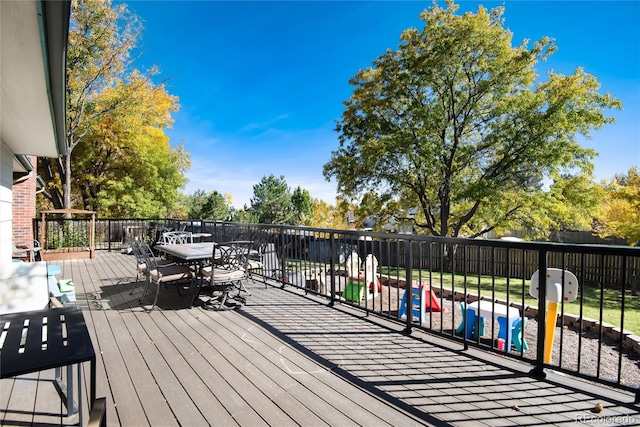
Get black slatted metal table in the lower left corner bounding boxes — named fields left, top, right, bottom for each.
left=0, top=306, right=96, bottom=425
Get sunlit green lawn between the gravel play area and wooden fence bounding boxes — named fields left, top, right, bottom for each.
left=382, top=267, right=640, bottom=334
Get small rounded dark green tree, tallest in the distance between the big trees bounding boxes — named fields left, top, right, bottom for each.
left=251, top=174, right=295, bottom=224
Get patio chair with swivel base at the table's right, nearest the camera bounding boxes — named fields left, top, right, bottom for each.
left=200, top=241, right=250, bottom=310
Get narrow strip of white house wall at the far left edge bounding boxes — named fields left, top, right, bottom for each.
left=0, top=143, right=13, bottom=263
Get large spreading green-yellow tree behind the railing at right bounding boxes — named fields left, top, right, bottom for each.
left=324, top=0, right=621, bottom=237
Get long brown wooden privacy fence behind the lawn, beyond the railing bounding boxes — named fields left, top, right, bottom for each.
left=62, top=218, right=640, bottom=289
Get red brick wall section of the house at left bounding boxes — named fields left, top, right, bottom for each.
left=13, top=157, right=37, bottom=243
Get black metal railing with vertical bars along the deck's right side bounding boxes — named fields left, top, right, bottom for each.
left=36, top=219, right=640, bottom=401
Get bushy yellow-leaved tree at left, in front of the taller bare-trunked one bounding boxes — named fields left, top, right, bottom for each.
left=71, top=73, right=189, bottom=217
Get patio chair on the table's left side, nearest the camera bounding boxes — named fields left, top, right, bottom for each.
left=139, top=243, right=195, bottom=312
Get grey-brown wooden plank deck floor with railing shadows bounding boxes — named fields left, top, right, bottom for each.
left=0, top=252, right=640, bottom=426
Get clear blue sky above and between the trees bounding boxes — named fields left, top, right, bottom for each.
left=125, top=0, right=640, bottom=208
